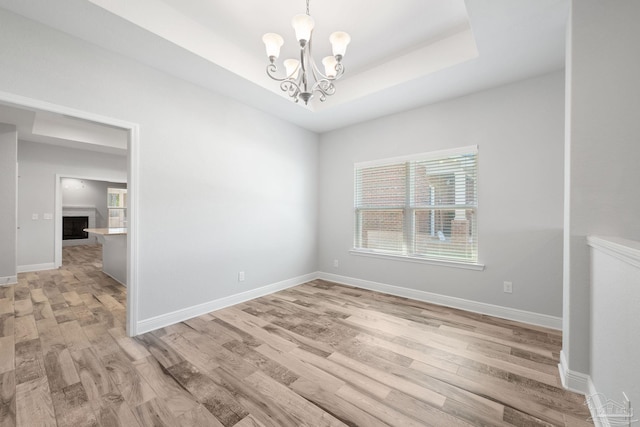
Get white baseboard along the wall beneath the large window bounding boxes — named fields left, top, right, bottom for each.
left=318, top=272, right=562, bottom=330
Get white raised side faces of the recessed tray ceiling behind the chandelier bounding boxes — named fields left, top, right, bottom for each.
left=88, top=0, right=478, bottom=111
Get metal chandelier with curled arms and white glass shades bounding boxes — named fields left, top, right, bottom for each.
left=262, top=0, right=351, bottom=105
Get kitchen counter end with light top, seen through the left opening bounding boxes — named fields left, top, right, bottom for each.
left=83, top=228, right=127, bottom=286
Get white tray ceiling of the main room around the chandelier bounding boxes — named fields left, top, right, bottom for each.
left=0, top=0, right=569, bottom=140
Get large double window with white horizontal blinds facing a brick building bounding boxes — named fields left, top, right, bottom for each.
left=354, top=146, right=478, bottom=264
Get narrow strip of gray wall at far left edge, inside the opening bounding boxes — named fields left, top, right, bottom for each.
left=0, top=123, right=18, bottom=286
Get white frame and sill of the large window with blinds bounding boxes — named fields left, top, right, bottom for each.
left=349, top=145, right=484, bottom=270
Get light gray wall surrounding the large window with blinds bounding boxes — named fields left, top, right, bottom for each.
left=319, top=72, right=564, bottom=316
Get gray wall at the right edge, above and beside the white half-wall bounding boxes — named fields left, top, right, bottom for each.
left=563, top=0, right=640, bottom=382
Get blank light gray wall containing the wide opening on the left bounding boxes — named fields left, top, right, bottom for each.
left=0, top=11, right=318, bottom=320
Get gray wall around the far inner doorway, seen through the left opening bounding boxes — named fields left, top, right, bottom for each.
left=18, top=141, right=127, bottom=271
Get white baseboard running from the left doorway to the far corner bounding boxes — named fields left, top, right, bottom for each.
left=136, top=273, right=318, bottom=334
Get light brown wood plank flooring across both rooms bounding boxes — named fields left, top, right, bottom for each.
left=0, top=246, right=590, bottom=427
